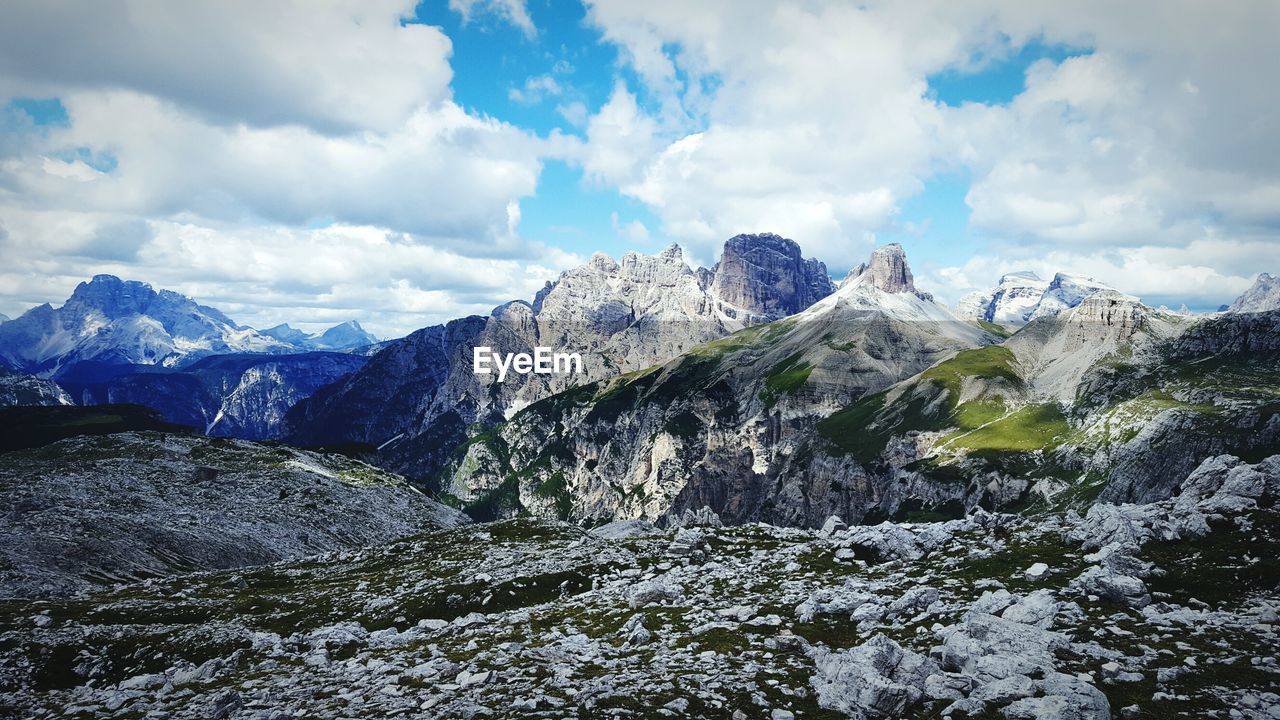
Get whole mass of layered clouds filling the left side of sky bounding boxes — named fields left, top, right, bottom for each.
left=0, top=0, right=576, bottom=336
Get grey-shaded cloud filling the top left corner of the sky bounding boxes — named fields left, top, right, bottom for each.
left=0, top=0, right=452, bottom=132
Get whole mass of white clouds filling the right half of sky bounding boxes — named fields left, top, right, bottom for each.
left=585, top=0, right=1280, bottom=299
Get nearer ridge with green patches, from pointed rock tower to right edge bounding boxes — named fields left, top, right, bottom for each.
left=432, top=235, right=1280, bottom=527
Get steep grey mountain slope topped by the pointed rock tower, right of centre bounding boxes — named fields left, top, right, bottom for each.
left=444, top=240, right=996, bottom=525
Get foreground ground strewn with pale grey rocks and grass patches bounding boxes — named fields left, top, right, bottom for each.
left=0, top=456, right=1280, bottom=720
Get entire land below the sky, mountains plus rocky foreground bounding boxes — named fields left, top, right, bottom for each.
left=0, top=234, right=1280, bottom=720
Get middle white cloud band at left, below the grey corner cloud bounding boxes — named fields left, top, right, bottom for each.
left=0, top=91, right=552, bottom=255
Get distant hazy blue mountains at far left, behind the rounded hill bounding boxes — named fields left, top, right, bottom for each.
left=0, top=275, right=379, bottom=439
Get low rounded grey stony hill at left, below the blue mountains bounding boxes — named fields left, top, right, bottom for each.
left=0, top=433, right=468, bottom=597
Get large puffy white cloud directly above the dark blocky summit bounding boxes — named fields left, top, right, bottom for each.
left=586, top=1, right=954, bottom=266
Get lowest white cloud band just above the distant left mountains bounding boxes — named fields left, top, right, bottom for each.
left=0, top=210, right=582, bottom=337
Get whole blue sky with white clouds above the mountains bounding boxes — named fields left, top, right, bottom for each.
left=0, top=0, right=1280, bottom=337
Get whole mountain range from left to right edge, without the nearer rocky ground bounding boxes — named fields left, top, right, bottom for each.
left=0, top=233, right=1277, bottom=509
